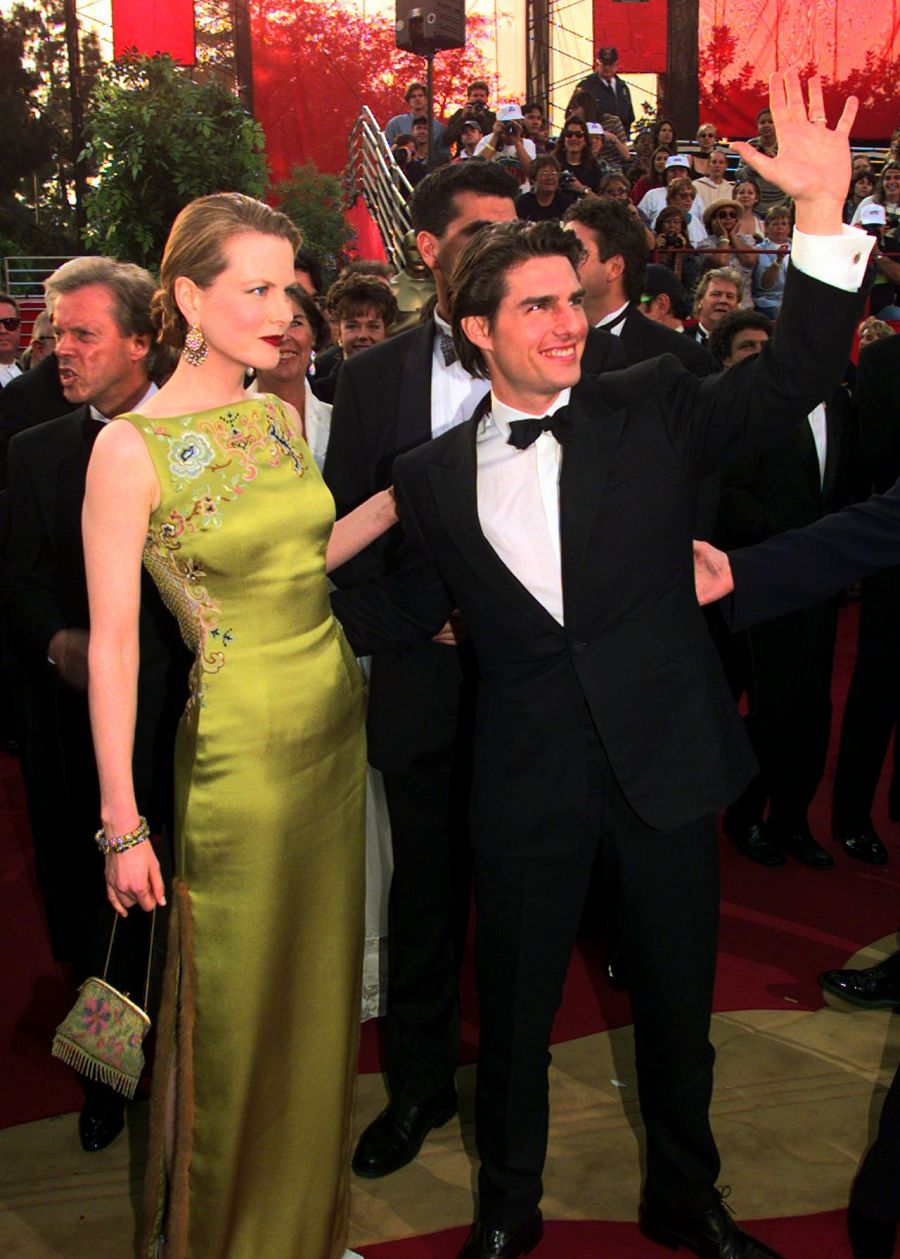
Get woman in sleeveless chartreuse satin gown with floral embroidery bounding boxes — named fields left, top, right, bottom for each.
left=84, top=194, right=395, bottom=1259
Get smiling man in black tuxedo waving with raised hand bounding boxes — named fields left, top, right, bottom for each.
left=334, top=74, right=870, bottom=1259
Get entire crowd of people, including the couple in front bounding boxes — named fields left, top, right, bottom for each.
left=0, top=63, right=900, bottom=1259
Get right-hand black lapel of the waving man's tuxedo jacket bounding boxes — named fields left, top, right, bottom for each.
left=559, top=395, right=626, bottom=606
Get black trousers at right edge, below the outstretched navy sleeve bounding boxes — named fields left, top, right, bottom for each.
left=832, top=568, right=900, bottom=838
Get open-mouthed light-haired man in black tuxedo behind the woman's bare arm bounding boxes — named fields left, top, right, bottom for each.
left=5, top=258, right=186, bottom=1151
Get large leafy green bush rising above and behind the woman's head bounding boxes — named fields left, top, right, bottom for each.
left=86, top=54, right=267, bottom=267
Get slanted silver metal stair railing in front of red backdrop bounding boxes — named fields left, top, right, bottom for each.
left=347, top=104, right=413, bottom=271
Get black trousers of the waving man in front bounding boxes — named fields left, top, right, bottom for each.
left=473, top=739, right=719, bottom=1228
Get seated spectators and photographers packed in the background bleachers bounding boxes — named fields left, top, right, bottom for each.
left=384, top=47, right=900, bottom=319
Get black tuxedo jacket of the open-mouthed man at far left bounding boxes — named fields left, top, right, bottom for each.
left=4, top=407, right=190, bottom=816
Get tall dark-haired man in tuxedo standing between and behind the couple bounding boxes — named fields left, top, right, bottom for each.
left=325, top=162, right=622, bottom=1177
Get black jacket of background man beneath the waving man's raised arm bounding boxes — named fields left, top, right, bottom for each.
left=715, top=388, right=865, bottom=549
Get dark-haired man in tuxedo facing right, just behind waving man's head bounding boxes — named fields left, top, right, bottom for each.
left=571, top=196, right=719, bottom=376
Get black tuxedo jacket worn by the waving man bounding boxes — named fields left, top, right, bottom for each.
left=334, top=265, right=860, bottom=855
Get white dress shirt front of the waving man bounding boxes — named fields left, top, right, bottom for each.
left=475, top=389, right=571, bottom=624
